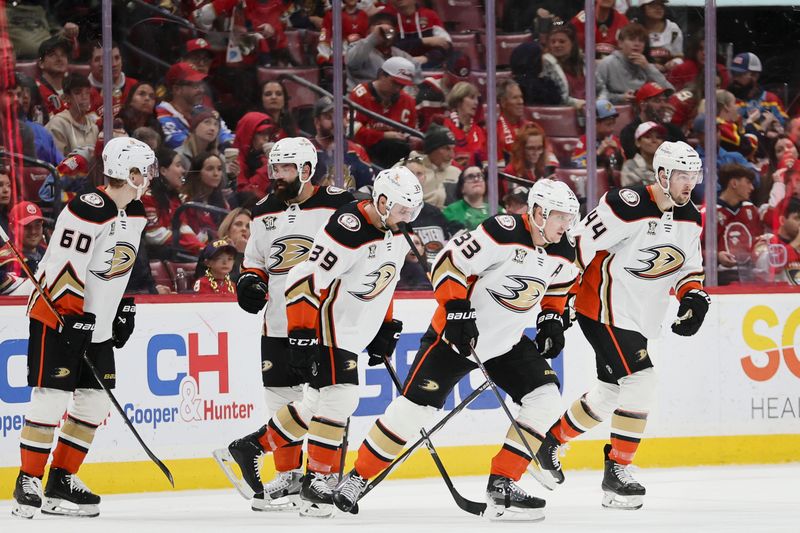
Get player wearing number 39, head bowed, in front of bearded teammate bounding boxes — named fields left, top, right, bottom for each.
left=248, top=167, right=422, bottom=516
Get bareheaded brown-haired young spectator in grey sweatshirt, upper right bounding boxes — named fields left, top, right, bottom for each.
left=597, top=22, right=673, bottom=104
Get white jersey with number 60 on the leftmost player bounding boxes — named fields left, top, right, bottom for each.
left=28, top=188, right=147, bottom=342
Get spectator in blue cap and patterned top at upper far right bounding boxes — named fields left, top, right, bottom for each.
left=728, top=52, right=789, bottom=131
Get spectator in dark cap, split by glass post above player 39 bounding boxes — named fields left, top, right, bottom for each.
left=311, top=96, right=373, bottom=189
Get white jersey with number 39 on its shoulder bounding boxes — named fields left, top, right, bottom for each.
left=286, top=201, right=411, bottom=354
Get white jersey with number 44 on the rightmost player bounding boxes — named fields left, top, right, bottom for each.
left=575, top=185, right=705, bottom=339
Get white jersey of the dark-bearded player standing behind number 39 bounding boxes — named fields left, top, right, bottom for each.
left=242, top=187, right=353, bottom=337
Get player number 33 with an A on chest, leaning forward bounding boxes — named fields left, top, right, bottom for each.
left=334, top=179, right=579, bottom=521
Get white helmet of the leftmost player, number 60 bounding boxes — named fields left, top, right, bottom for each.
left=103, top=137, right=158, bottom=200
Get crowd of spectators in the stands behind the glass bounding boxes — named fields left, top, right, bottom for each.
left=0, top=0, right=800, bottom=296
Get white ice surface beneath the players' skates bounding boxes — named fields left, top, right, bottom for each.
left=0, top=464, right=800, bottom=533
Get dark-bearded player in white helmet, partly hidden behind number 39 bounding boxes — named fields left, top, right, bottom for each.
left=215, top=137, right=353, bottom=511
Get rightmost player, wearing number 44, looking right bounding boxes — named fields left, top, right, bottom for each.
left=537, top=142, right=710, bottom=509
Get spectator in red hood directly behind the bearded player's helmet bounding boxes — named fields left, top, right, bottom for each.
left=233, top=111, right=275, bottom=198
